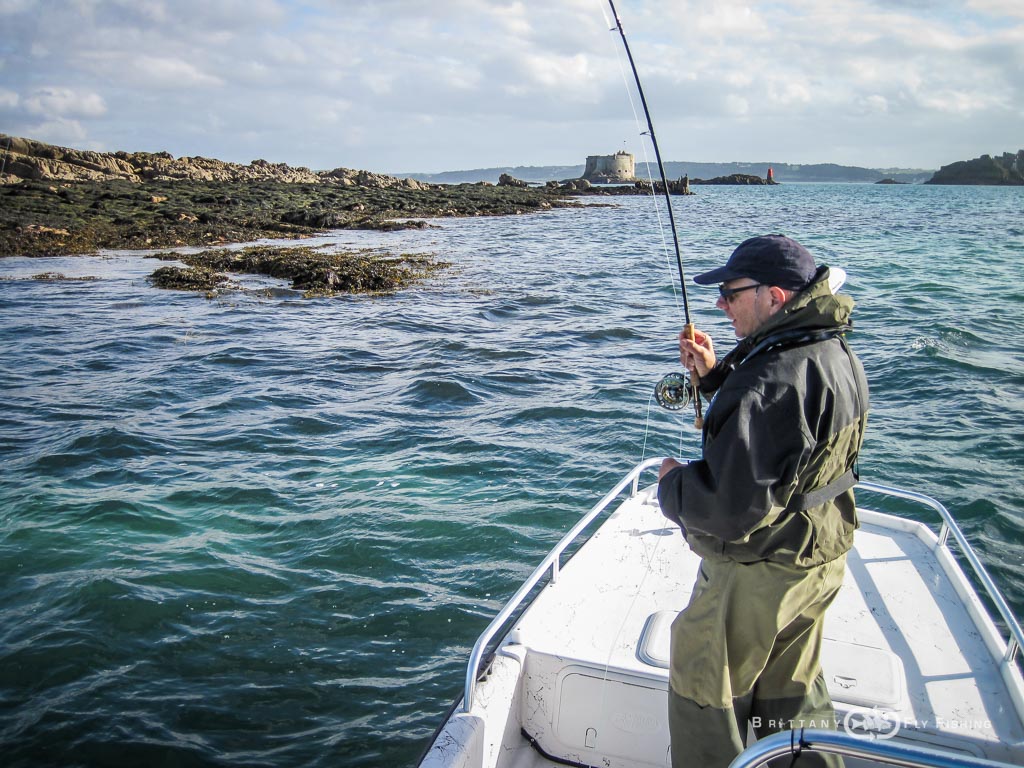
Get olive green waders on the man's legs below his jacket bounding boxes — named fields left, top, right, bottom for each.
left=669, top=555, right=846, bottom=768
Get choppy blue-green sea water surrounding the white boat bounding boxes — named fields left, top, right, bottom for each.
left=0, top=184, right=1024, bottom=768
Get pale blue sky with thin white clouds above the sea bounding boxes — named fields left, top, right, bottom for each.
left=0, top=0, right=1024, bottom=173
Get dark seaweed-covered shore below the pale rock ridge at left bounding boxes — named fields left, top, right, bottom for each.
left=0, top=174, right=575, bottom=258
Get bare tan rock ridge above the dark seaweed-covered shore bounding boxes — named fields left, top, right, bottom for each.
left=0, top=134, right=430, bottom=189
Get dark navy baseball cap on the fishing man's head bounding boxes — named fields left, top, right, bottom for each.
left=693, top=234, right=817, bottom=291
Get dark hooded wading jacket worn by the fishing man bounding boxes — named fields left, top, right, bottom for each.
left=658, top=267, right=868, bottom=567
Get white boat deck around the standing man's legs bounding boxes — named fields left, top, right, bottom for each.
left=462, top=488, right=1024, bottom=768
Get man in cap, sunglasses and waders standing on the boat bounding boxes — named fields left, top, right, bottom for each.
left=658, top=234, right=867, bottom=768
